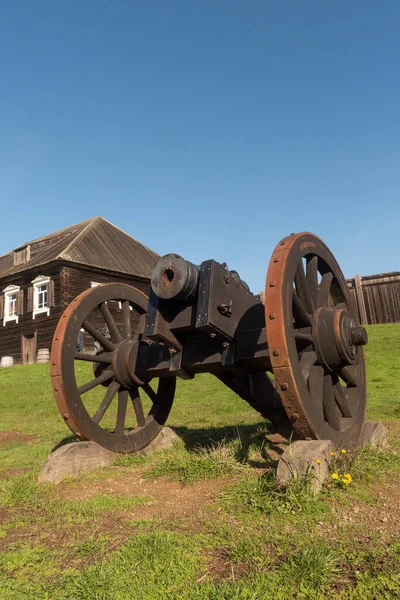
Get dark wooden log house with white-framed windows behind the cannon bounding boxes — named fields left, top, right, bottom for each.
left=0, top=216, right=159, bottom=364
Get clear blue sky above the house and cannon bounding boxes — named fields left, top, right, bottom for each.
left=0, top=0, right=400, bottom=291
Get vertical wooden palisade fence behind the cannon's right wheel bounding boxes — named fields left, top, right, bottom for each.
left=347, top=272, right=400, bottom=325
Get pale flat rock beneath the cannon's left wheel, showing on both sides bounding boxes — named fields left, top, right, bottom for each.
left=38, top=427, right=180, bottom=485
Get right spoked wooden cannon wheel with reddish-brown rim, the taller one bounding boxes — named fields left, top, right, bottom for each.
left=265, top=233, right=367, bottom=446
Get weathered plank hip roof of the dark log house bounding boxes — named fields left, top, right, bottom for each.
left=0, top=216, right=159, bottom=279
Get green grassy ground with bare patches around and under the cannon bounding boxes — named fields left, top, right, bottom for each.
left=0, top=325, right=400, bottom=600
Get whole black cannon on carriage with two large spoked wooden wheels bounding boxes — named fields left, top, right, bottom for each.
left=50, top=233, right=367, bottom=453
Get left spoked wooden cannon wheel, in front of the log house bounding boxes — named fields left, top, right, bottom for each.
left=50, top=283, right=175, bottom=453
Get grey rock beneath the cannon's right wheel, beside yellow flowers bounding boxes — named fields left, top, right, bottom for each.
left=276, top=440, right=335, bottom=494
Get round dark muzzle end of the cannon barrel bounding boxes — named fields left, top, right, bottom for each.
left=151, top=254, right=199, bottom=303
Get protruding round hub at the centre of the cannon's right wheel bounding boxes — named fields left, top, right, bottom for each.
left=312, top=307, right=368, bottom=371
